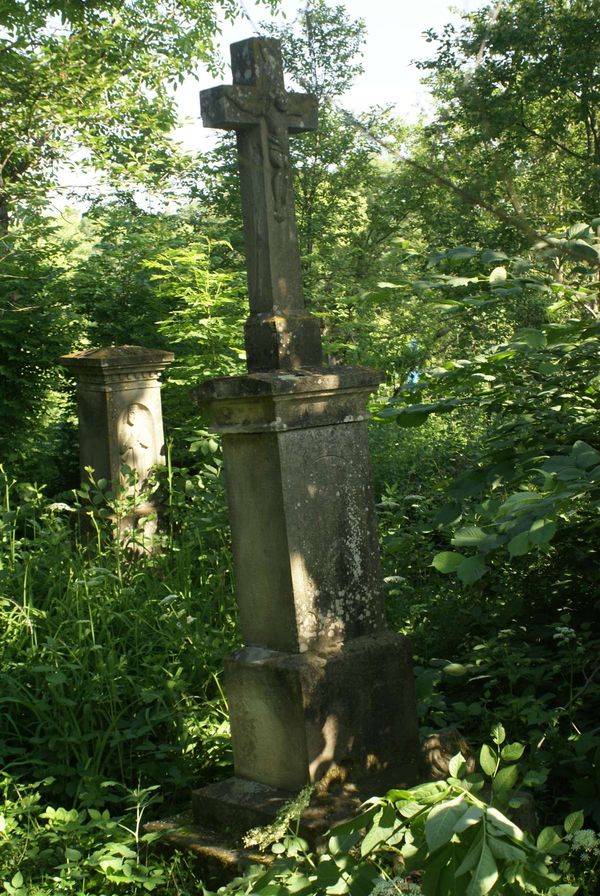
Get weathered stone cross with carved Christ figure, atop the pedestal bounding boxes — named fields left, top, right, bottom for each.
left=200, top=37, right=321, bottom=372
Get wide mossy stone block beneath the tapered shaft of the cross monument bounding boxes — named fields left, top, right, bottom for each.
left=225, top=631, right=420, bottom=792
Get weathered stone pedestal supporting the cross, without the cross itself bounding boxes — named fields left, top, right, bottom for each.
left=194, top=368, right=419, bottom=821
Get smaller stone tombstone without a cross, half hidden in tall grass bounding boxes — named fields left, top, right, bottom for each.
left=60, top=345, right=174, bottom=546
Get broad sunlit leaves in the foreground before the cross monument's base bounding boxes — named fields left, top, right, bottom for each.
left=209, top=724, right=583, bottom=896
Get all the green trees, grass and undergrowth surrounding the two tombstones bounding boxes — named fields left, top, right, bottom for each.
left=0, top=0, right=600, bottom=896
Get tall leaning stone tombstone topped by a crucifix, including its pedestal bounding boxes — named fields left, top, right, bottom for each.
left=193, top=38, right=419, bottom=826
